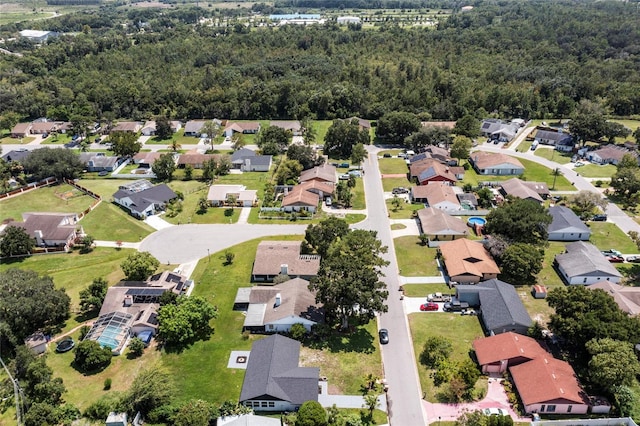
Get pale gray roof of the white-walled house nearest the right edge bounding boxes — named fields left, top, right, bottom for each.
left=556, top=241, right=622, bottom=277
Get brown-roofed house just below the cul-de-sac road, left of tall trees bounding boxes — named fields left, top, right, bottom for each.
left=251, top=241, right=320, bottom=281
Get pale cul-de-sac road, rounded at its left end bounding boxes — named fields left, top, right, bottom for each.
left=140, top=224, right=307, bottom=263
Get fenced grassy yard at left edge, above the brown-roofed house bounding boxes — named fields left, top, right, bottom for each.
left=0, top=184, right=95, bottom=221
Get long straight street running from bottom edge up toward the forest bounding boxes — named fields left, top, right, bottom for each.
left=356, top=146, right=427, bottom=426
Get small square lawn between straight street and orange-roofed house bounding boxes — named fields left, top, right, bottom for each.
left=393, top=236, right=440, bottom=277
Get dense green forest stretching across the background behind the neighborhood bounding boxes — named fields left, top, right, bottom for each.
left=0, top=1, right=640, bottom=123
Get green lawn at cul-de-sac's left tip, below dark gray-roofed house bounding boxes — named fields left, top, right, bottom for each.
left=80, top=200, right=154, bottom=242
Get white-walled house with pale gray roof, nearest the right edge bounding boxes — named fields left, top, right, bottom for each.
left=554, top=241, right=622, bottom=285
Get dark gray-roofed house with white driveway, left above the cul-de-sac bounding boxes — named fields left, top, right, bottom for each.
left=113, top=181, right=178, bottom=219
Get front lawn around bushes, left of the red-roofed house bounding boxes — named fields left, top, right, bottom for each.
left=409, top=313, right=486, bottom=402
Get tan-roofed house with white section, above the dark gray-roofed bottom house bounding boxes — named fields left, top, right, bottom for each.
left=234, top=278, right=324, bottom=333
